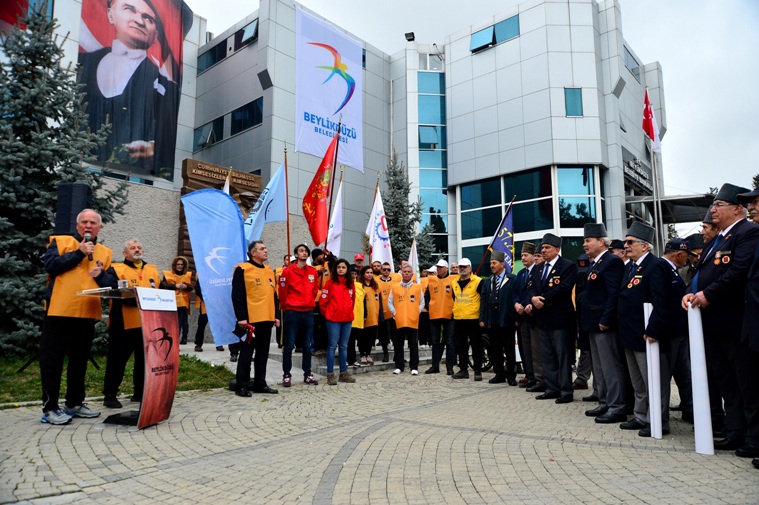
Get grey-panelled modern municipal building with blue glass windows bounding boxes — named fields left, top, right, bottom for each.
left=20, top=0, right=667, bottom=261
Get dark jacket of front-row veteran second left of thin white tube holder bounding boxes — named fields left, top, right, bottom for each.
left=527, top=256, right=577, bottom=332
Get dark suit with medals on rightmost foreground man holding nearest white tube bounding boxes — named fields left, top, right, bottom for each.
left=689, top=219, right=759, bottom=444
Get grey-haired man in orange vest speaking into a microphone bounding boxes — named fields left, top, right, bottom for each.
left=40, top=209, right=116, bottom=424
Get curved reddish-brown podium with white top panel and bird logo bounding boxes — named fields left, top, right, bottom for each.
left=78, top=287, right=179, bottom=430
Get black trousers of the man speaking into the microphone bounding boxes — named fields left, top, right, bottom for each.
left=40, top=316, right=95, bottom=412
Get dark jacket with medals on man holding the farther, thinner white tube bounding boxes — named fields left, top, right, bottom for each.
left=617, top=253, right=683, bottom=352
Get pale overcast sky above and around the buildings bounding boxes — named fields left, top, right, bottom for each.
left=185, top=0, right=759, bottom=231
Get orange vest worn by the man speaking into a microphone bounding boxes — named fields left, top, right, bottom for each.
left=47, top=235, right=113, bottom=319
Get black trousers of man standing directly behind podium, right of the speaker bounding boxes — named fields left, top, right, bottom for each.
left=103, top=328, right=145, bottom=398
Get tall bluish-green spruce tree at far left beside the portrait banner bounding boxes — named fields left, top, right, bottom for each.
left=0, top=4, right=127, bottom=352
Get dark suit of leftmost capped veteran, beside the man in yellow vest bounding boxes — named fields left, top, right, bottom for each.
left=480, top=272, right=516, bottom=380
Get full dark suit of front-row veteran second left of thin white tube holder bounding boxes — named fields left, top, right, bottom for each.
left=527, top=256, right=577, bottom=397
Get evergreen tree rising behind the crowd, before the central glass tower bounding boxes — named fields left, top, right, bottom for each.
left=382, top=149, right=434, bottom=267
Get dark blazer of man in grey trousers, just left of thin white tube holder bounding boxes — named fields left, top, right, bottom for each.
left=578, top=251, right=625, bottom=333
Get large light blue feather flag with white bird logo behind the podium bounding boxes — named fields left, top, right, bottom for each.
left=182, top=189, right=246, bottom=346
